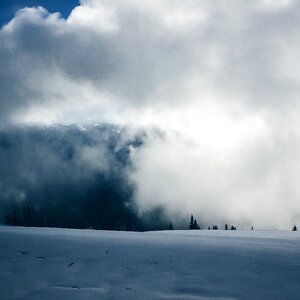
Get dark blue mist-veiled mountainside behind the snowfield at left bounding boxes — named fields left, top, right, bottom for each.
left=0, top=125, right=142, bottom=229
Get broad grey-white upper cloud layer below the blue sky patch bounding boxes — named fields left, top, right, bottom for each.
left=0, top=0, right=299, bottom=122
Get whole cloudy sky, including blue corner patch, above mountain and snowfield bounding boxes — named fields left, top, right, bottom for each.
left=0, top=0, right=300, bottom=228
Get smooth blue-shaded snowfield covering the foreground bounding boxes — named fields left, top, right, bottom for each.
left=0, top=226, right=300, bottom=300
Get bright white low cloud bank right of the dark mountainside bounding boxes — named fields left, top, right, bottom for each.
left=131, top=125, right=300, bottom=229
